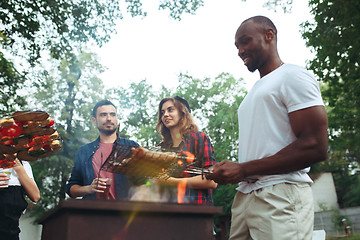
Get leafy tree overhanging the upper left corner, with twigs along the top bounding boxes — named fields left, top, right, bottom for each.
left=0, top=0, right=203, bottom=118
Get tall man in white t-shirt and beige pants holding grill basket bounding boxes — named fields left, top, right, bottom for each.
left=206, top=16, right=328, bottom=240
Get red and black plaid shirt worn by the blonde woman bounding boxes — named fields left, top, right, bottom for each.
left=159, top=132, right=216, bottom=205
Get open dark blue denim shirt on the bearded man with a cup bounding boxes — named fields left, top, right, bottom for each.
left=65, top=137, right=139, bottom=200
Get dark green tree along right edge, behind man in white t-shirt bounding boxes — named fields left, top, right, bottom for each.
left=303, top=0, right=360, bottom=207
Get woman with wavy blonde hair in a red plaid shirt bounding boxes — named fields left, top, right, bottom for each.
left=156, top=96, right=217, bottom=205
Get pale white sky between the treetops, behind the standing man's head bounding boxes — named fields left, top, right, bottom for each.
left=95, top=0, right=313, bottom=89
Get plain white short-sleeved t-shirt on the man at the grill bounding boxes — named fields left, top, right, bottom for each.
left=237, top=64, right=324, bottom=193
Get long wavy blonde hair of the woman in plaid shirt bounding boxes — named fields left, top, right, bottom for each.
left=156, top=97, right=199, bottom=143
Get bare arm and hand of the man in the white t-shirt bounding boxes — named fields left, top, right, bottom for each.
left=207, top=106, right=328, bottom=184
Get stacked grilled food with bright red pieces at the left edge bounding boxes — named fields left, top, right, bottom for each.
left=0, top=111, right=61, bottom=167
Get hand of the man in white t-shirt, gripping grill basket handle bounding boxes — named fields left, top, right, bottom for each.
left=205, top=160, right=245, bottom=185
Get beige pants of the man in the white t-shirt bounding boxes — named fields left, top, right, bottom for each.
left=230, top=183, right=314, bottom=240
